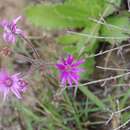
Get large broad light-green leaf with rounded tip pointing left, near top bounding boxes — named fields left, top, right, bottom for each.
left=26, top=4, right=86, bottom=29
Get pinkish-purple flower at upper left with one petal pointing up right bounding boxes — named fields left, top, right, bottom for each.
left=1, top=16, right=24, bottom=43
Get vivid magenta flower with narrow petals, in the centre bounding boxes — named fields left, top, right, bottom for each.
left=56, top=55, right=84, bottom=87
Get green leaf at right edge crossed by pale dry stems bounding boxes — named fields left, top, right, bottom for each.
left=101, top=16, right=130, bottom=43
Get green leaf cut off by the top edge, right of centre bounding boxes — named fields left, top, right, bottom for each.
left=66, top=0, right=121, bottom=17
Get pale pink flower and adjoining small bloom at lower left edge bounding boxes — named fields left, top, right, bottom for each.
left=0, top=69, right=27, bottom=100
